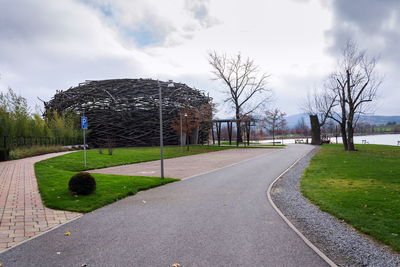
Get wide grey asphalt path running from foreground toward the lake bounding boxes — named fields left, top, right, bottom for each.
left=0, top=145, right=327, bottom=267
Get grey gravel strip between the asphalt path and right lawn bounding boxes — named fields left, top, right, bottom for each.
left=271, top=151, right=400, bottom=266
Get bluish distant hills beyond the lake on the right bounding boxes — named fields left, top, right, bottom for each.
left=286, top=113, right=400, bottom=128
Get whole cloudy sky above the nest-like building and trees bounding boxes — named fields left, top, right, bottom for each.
left=0, top=0, right=400, bottom=116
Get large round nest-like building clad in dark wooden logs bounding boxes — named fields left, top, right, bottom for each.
left=44, top=79, right=212, bottom=147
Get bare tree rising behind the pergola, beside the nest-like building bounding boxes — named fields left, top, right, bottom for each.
left=208, top=51, right=271, bottom=145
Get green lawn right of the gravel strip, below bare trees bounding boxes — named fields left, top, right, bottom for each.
left=301, top=145, right=400, bottom=251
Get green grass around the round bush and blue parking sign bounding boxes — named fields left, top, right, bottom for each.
left=35, top=146, right=233, bottom=212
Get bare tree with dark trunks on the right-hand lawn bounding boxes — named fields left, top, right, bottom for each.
left=328, top=41, right=382, bottom=151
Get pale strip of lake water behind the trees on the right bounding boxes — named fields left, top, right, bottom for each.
left=260, top=134, right=400, bottom=146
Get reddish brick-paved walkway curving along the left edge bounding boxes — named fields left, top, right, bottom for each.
left=0, top=152, right=81, bottom=250
